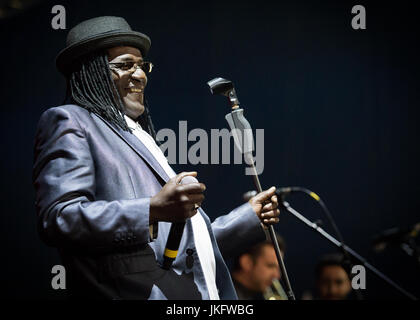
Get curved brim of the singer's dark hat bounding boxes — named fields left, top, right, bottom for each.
left=55, top=31, right=151, bottom=75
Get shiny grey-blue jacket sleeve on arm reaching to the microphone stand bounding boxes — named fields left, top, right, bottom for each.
left=211, top=203, right=266, bottom=259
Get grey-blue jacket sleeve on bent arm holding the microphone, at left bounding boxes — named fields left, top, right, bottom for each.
left=32, top=107, right=150, bottom=251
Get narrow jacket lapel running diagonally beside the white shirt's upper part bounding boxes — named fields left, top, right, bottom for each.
left=95, top=114, right=169, bottom=182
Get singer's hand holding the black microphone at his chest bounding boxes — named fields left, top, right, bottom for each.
left=149, top=171, right=206, bottom=224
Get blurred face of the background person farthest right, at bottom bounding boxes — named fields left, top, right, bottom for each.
left=318, top=266, right=351, bottom=300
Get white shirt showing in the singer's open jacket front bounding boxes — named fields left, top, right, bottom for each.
left=124, top=115, right=220, bottom=300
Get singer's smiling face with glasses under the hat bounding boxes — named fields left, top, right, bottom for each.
left=107, top=46, right=147, bottom=120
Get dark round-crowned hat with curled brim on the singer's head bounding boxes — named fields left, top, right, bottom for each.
left=55, top=16, right=151, bottom=74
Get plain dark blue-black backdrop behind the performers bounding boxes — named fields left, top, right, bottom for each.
left=0, top=0, right=420, bottom=299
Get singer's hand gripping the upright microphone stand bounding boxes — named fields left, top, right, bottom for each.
left=248, top=187, right=280, bottom=226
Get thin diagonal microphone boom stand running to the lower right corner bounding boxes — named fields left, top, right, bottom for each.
left=279, top=197, right=417, bottom=300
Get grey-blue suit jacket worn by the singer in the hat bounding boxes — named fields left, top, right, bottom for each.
left=33, top=105, right=265, bottom=299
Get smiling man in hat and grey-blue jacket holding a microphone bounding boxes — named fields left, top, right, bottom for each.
left=33, top=17, right=279, bottom=299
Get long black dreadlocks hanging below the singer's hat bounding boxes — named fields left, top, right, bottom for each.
left=64, top=50, right=156, bottom=141
